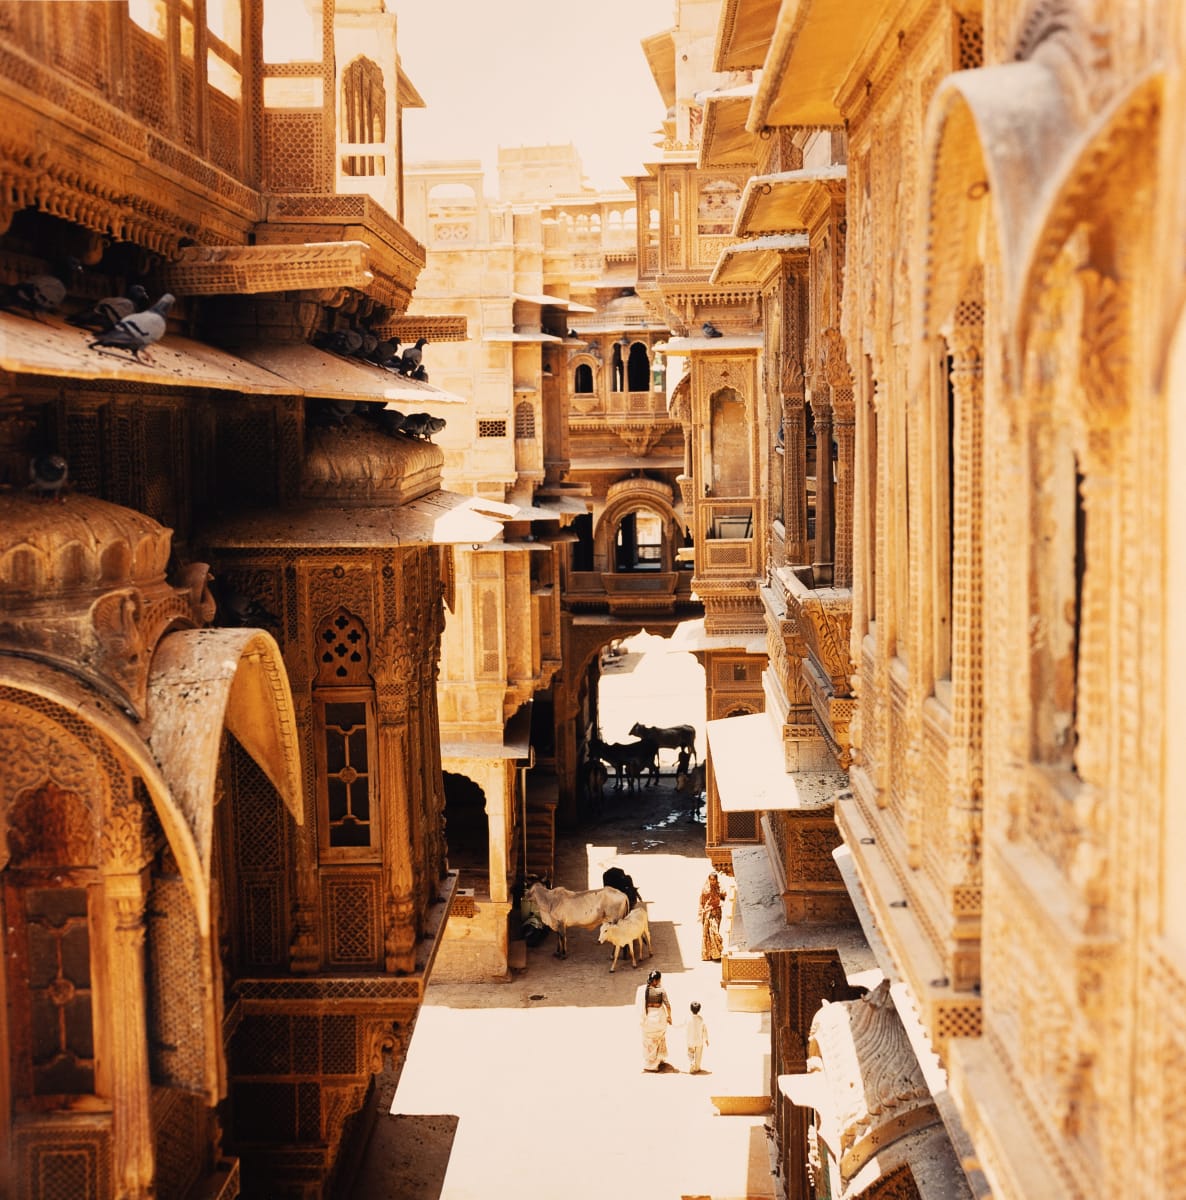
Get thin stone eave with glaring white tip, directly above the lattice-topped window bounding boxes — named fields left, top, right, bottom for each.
left=202, top=491, right=504, bottom=548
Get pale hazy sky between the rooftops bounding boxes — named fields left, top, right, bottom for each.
left=388, top=0, right=675, bottom=196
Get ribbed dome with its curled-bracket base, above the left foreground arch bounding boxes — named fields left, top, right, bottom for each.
left=0, top=493, right=214, bottom=716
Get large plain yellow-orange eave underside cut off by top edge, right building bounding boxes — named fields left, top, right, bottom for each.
left=749, top=0, right=897, bottom=133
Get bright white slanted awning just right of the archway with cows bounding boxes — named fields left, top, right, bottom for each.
left=705, top=713, right=849, bottom=812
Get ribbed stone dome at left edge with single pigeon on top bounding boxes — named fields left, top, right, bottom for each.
left=0, top=492, right=173, bottom=600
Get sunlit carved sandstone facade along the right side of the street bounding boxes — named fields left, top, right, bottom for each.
left=657, top=0, right=1186, bottom=1198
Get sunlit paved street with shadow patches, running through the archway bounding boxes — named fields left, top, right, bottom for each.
left=355, top=638, right=774, bottom=1200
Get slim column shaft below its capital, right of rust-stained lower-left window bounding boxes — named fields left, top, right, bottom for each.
left=103, top=871, right=155, bottom=1200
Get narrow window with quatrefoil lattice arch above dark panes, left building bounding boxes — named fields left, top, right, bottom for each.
left=313, top=608, right=379, bottom=859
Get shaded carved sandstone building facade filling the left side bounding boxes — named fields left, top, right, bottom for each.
left=0, top=0, right=463, bottom=1200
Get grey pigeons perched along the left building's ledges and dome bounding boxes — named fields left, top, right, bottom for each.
left=0, top=258, right=445, bottom=500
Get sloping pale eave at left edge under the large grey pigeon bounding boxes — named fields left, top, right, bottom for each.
left=0, top=312, right=300, bottom=396
